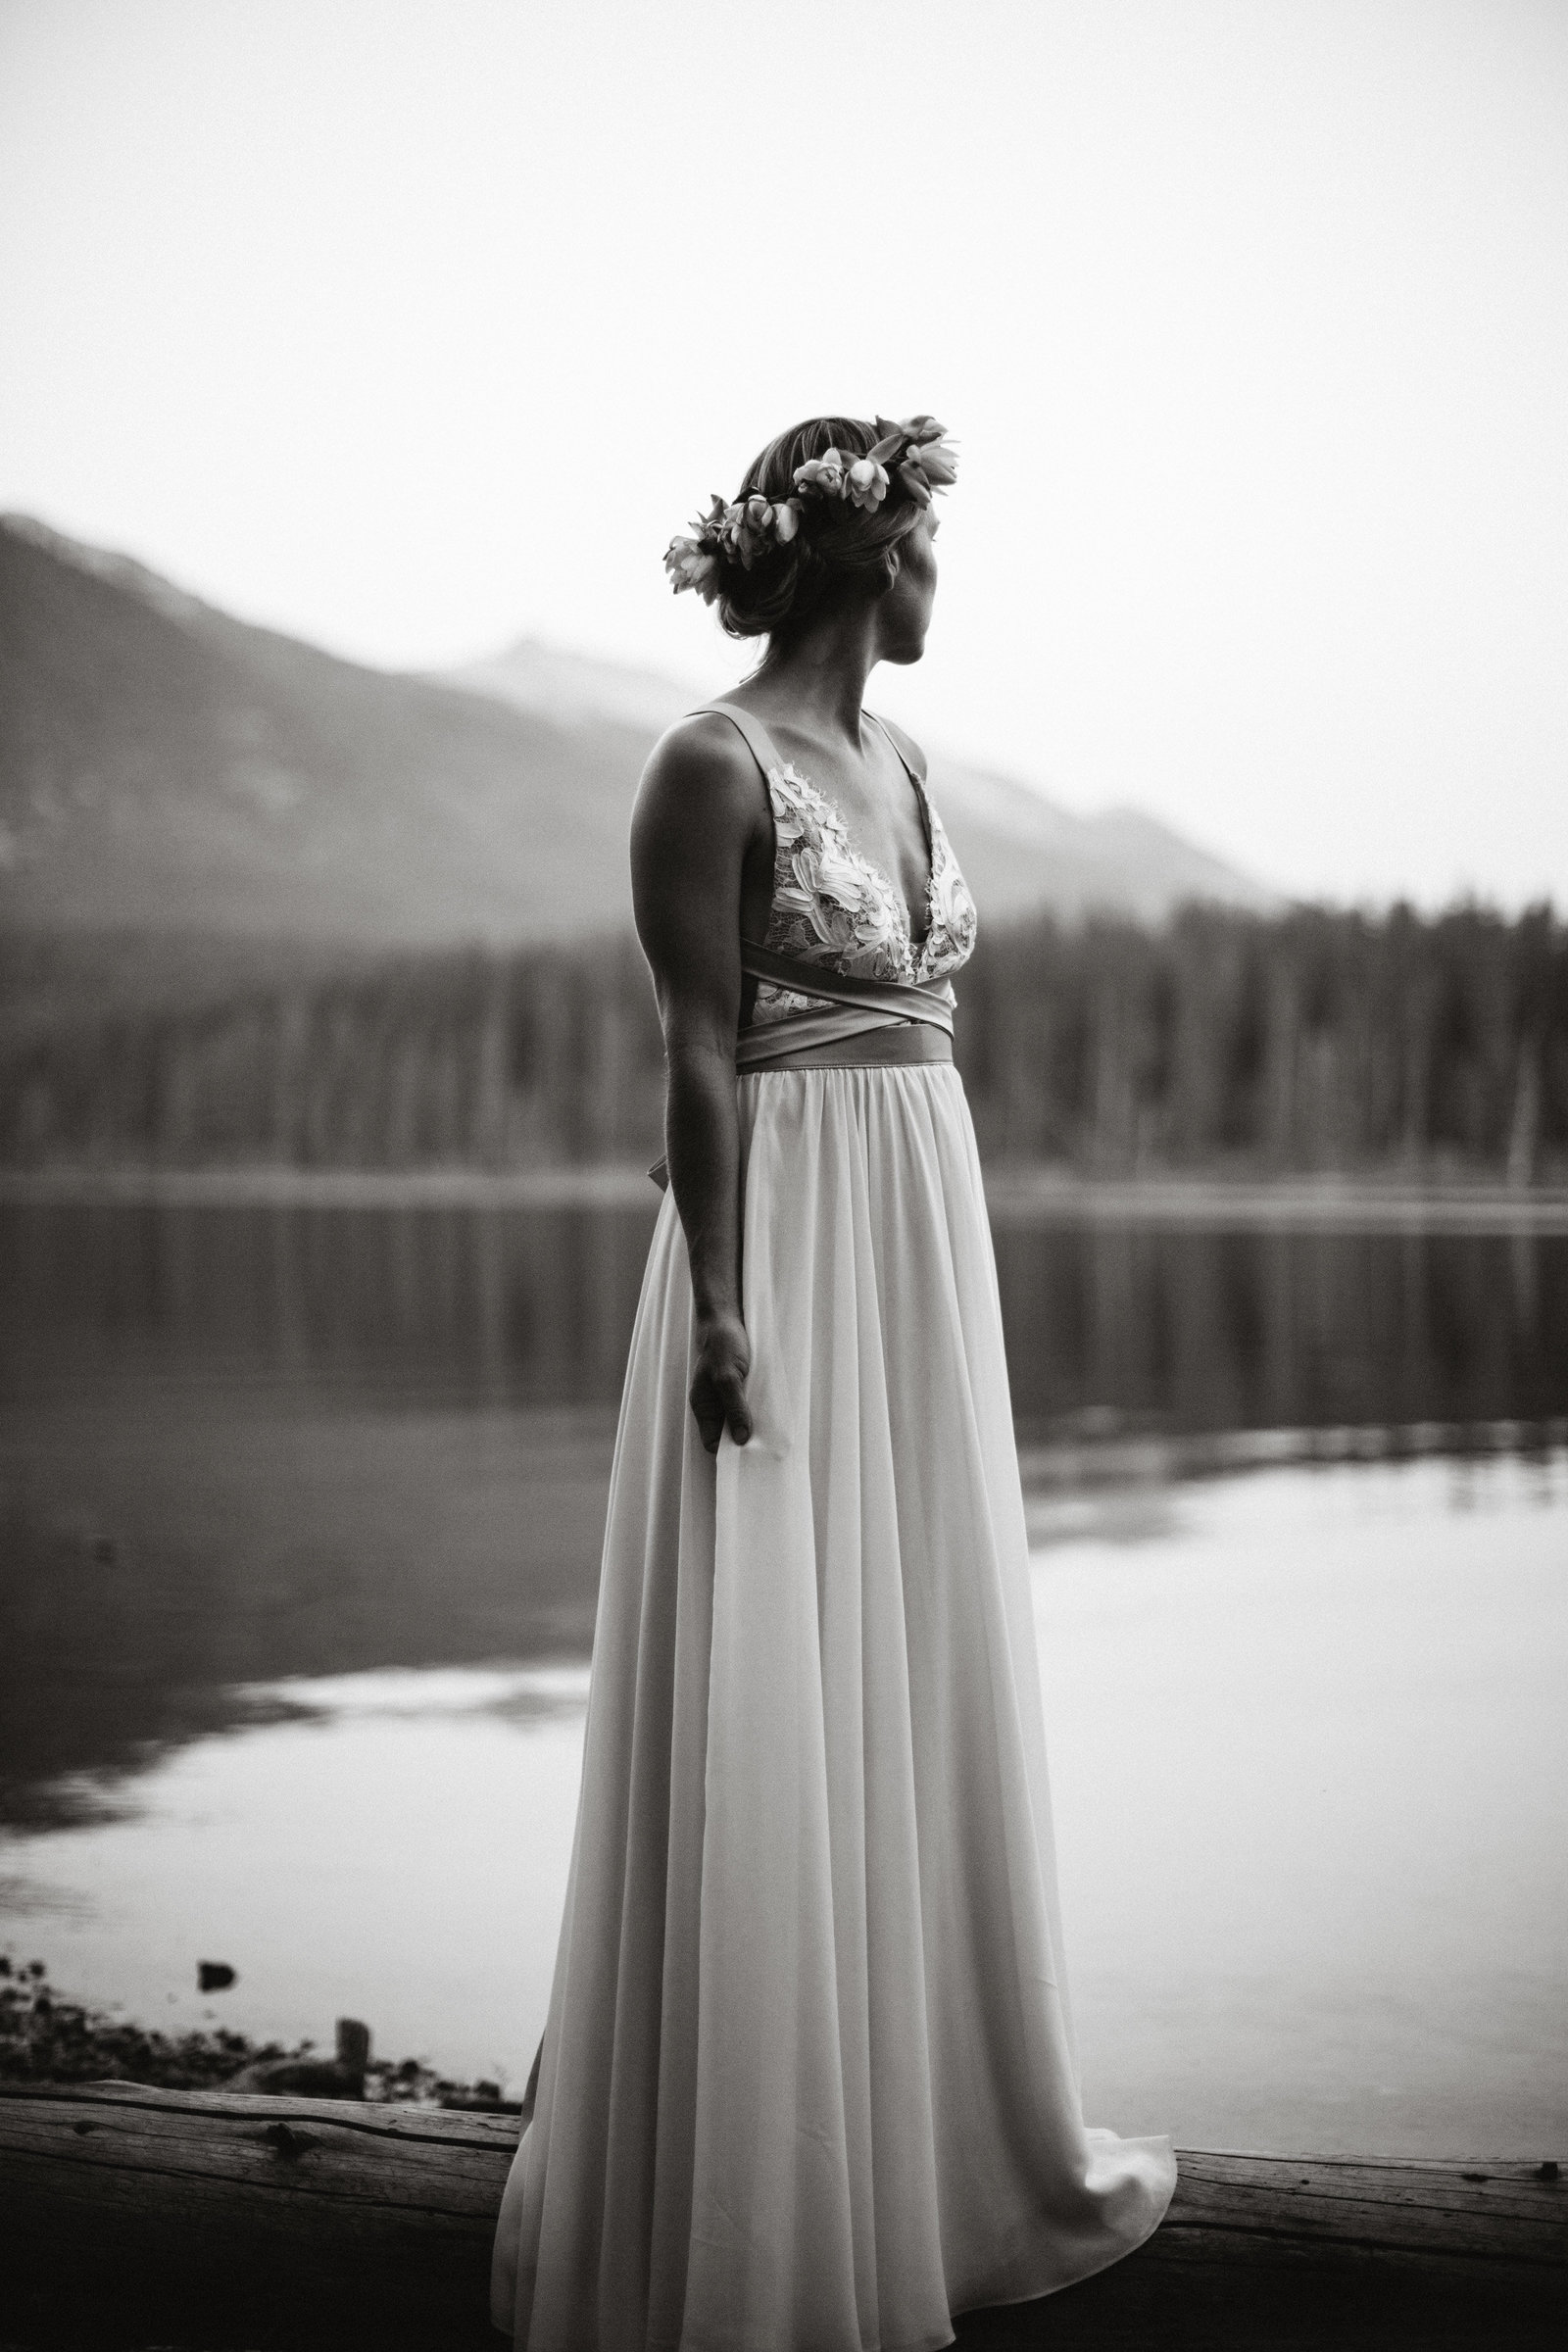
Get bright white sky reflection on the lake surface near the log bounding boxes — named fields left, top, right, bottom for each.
left=0, top=1451, right=1568, bottom=2157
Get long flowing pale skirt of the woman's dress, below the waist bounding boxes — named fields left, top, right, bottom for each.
left=494, top=1063, right=1175, bottom=2352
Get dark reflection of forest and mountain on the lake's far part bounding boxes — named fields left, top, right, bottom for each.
left=0, top=1195, right=1568, bottom=1823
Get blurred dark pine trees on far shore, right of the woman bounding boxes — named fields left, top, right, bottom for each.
left=964, top=907, right=1568, bottom=1181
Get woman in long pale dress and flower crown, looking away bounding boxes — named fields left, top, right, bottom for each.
left=494, top=416, right=1175, bottom=2352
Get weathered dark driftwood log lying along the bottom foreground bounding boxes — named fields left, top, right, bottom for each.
left=0, top=2083, right=1568, bottom=2352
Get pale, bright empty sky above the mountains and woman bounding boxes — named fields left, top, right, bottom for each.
left=0, top=0, right=1568, bottom=907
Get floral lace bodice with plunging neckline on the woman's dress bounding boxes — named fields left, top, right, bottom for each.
left=753, top=733, right=978, bottom=1025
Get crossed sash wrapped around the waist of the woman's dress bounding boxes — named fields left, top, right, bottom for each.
left=649, top=939, right=953, bottom=1193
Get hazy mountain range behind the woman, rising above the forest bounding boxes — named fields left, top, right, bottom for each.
left=0, top=517, right=1262, bottom=948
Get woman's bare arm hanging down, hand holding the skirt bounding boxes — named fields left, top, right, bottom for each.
left=632, top=717, right=766, bottom=1453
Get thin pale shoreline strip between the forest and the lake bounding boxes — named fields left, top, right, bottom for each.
left=0, top=1162, right=1568, bottom=1233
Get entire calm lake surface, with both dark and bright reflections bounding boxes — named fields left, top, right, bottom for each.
left=0, top=1206, right=1568, bottom=2154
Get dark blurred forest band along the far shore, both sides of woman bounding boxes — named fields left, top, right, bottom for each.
left=0, top=906, right=1568, bottom=1183
